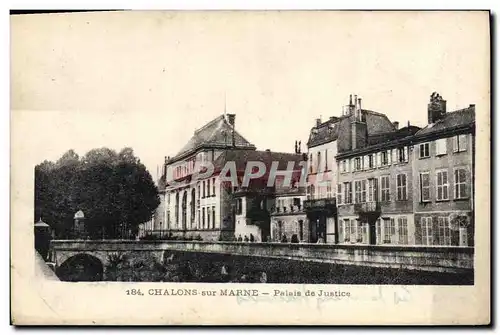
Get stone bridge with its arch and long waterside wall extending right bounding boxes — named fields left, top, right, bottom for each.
left=50, top=240, right=474, bottom=280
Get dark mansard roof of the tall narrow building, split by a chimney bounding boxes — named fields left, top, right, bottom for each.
left=307, top=109, right=395, bottom=147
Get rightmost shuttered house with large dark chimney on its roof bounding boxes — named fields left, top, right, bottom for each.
left=413, top=94, right=475, bottom=246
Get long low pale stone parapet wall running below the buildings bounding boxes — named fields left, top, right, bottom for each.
left=51, top=240, right=474, bottom=272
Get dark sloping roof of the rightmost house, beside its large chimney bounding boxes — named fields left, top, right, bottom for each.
left=415, top=105, right=476, bottom=137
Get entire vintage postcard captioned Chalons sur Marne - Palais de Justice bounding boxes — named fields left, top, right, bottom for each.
left=10, top=11, right=491, bottom=325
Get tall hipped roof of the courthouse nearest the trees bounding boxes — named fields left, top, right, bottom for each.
left=172, top=114, right=255, bottom=160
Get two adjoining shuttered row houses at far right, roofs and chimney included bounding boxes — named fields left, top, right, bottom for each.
left=336, top=94, right=475, bottom=246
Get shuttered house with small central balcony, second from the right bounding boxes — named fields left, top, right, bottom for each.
left=337, top=126, right=419, bottom=244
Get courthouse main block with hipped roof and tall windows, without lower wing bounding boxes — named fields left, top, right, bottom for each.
left=151, top=114, right=256, bottom=241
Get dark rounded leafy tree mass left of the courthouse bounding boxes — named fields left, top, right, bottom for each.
left=35, top=148, right=160, bottom=238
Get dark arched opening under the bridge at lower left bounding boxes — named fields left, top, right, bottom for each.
left=56, top=253, right=104, bottom=282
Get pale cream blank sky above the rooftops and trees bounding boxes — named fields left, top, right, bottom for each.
left=10, top=11, right=490, bottom=178
